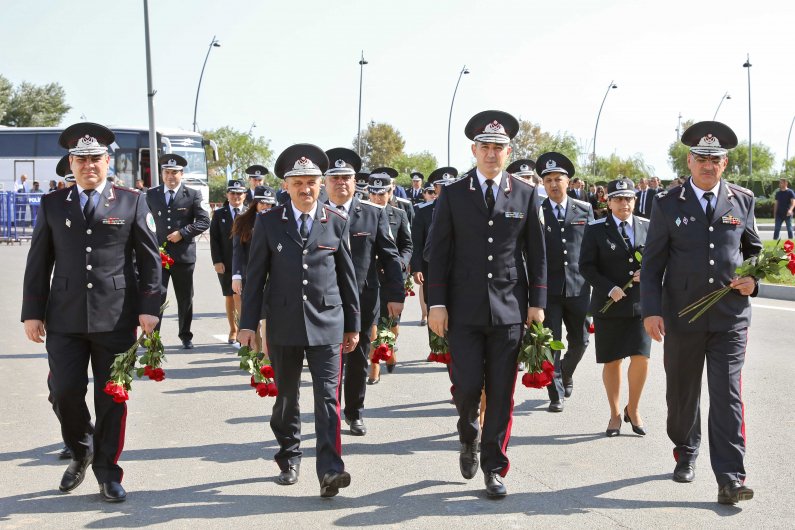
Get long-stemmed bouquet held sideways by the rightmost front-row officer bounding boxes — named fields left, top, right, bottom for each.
left=679, top=240, right=795, bottom=324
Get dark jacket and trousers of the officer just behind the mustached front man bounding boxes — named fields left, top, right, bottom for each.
left=330, top=198, right=406, bottom=421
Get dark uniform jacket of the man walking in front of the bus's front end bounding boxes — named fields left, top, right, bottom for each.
left=146, top=182, right=210, bottom=263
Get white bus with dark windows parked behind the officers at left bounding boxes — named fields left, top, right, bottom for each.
left=0, top=127, right=218, bottom=211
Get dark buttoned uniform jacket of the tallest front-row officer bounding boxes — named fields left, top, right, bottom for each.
left=428, top=170, right=547, bottom=326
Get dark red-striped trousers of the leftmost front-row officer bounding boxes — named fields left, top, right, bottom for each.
left=47, top=329, right=135, bottom=482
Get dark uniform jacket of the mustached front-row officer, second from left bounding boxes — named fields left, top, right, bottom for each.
left=240, top=202, right=360, bottom=346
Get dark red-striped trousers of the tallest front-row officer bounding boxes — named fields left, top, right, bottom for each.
left=447, top=324, right=523, bottom=477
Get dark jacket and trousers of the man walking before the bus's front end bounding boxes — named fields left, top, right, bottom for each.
left=146, top=183, right=210, bottom=341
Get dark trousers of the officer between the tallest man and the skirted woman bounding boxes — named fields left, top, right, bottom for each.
left=544, top=294, right=590, bottom=401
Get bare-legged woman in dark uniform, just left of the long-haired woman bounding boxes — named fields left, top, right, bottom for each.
left=210, top=180, right=246, bottom=344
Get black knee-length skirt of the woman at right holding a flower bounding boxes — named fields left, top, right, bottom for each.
left=593, top=317, right=651, bottom=364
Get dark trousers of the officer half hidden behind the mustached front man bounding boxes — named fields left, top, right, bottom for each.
left=340, top=288, right=379, bottom=421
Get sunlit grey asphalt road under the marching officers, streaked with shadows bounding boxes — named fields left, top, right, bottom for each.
left=0, top=242, right=795, bottom=529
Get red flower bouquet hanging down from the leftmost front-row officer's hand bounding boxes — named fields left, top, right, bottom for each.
left=104, top=302, right=168, bottom=403
